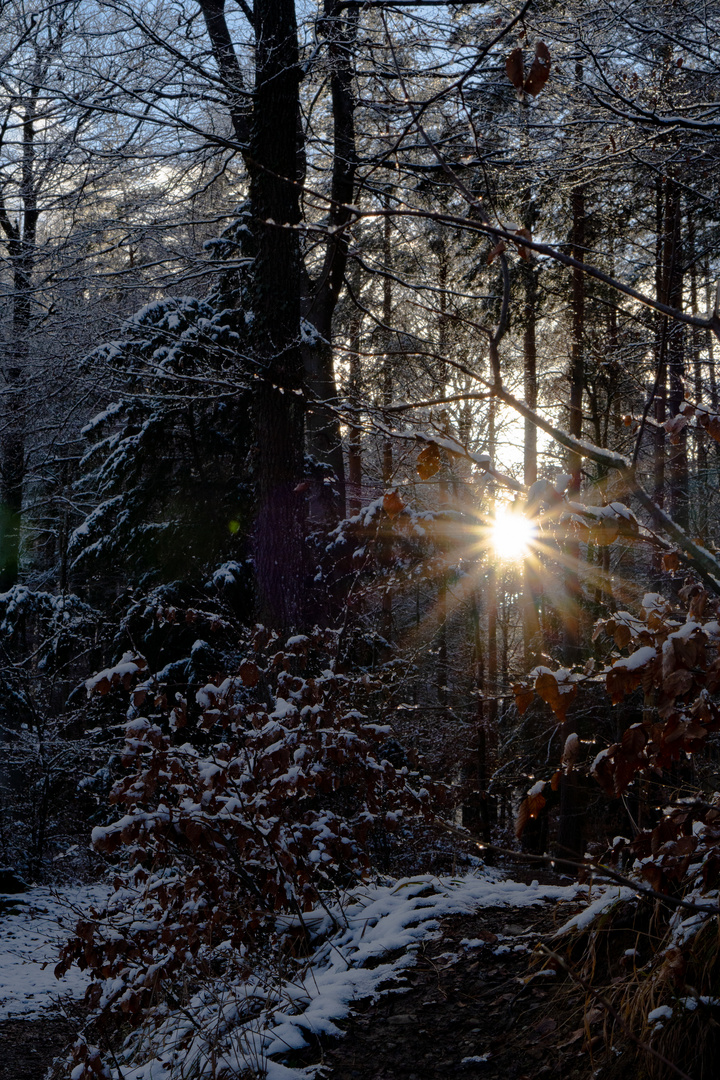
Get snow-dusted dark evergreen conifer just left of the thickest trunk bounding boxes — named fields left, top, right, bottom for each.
left=70, top=297, right=252, bottom=583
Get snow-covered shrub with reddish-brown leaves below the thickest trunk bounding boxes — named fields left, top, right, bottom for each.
left=59, top=629, right=429, bottom=1076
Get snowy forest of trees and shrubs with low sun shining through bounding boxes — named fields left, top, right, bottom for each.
left=0, top=0, right=720, bottom=1080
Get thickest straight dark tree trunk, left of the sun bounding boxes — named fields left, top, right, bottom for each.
left=249, top=0, right=304, bottom=626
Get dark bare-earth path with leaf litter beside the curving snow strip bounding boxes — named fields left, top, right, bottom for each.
left=315, top=885, right=601, bottom=1080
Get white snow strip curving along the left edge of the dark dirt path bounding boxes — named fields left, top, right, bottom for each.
left=112, top=867, right=586, bottom=1080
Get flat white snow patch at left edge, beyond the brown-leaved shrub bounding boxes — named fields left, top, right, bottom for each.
left=0, top=886, right=107, bottom=1020
